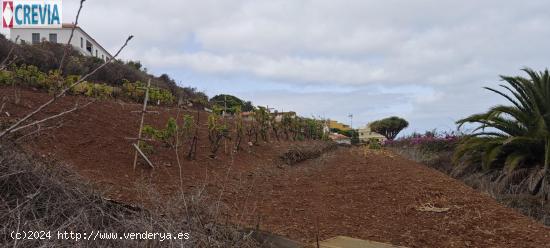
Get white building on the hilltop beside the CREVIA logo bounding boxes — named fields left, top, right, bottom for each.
left=9, top=24, right=112, bottom=60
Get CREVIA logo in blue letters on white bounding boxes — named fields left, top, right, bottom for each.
left=2, top=0, right=63, bottom=28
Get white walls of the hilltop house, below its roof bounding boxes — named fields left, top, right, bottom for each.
left=10, top=28, right=110, bottom=59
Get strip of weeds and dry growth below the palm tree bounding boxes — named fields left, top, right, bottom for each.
left=385, top=131, right=550, bottom=226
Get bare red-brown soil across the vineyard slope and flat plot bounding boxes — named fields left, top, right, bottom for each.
left=0, top=88, right=550, bottom=247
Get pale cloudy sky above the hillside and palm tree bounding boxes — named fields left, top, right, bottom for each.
left=2, top=0, right=550, bottom=132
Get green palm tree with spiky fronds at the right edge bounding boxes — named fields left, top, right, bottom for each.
left=455, top=69, right=550, bottom=200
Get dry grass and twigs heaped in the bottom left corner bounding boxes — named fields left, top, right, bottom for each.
left=0, top=140, right=259, bottom=247
